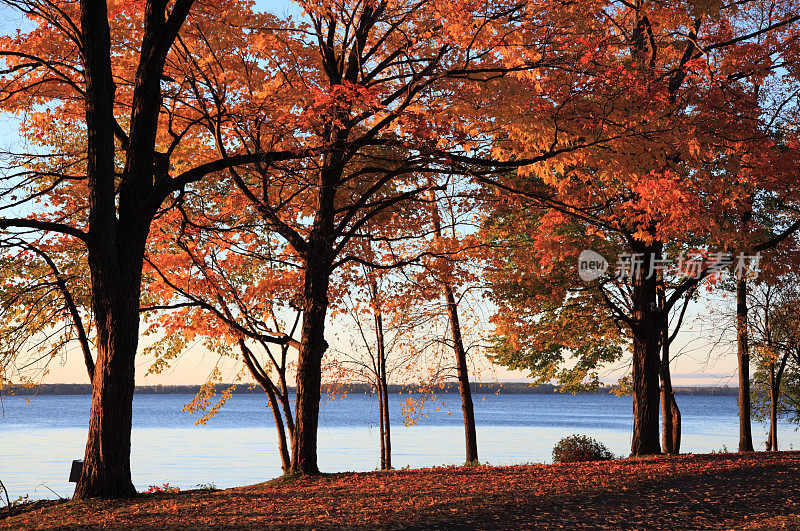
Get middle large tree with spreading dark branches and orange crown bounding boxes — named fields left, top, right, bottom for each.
left=167, top=1, right=612, bottom=474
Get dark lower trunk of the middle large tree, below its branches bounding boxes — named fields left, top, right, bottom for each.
left=291, top=264, right=330, bottom=475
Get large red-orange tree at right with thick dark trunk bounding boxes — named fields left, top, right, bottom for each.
left=483, top=2, right=798, bottom=455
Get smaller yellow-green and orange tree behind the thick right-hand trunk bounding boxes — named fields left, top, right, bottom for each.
left=483, top=203, right=708, bottom=453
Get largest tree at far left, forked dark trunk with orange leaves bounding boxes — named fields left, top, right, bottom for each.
left=0, top=0, right=302, bottom=498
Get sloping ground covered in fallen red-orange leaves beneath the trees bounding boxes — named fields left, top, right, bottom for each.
left=0, top=452, right=800, bottom=529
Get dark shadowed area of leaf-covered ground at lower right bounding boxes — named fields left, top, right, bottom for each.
left=418, top=455, right=800, bottom=529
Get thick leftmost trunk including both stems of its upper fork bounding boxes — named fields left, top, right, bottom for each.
left=75, top=0, right=191, bottom=499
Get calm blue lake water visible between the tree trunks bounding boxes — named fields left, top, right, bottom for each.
left=0, top=394, right=800, bottom=505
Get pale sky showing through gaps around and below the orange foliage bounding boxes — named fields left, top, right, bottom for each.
left=0, top=0, right=748, bottom=386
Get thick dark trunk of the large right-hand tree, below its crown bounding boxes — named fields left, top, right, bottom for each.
left=631, top=243, right=662, bottom=456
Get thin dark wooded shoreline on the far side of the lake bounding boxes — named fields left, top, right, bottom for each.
left=0, top=382, right=739, bottom=396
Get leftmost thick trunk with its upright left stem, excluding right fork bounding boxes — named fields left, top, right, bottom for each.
left=75, top=1, right=140, bottom=499
